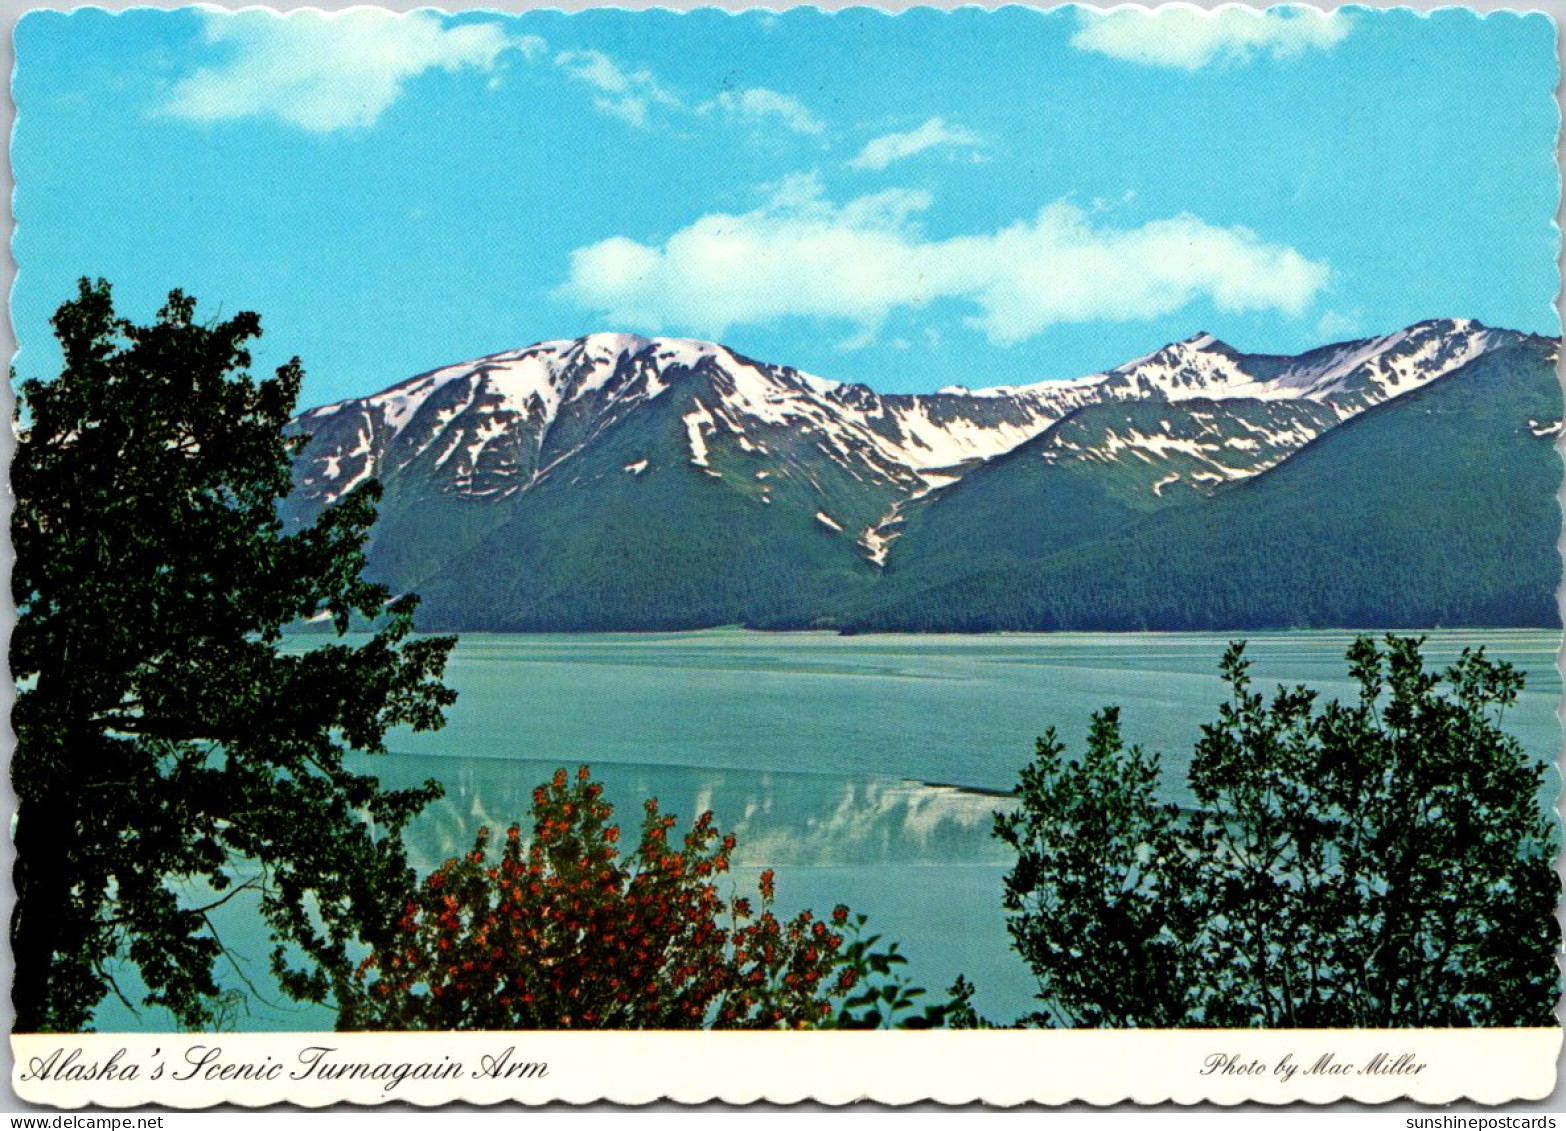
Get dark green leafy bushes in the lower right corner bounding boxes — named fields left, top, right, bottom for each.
left=996, top=636, right=1560, bottom=1028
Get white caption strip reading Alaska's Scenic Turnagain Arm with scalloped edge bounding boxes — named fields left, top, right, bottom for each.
left=11, top=1029, right=1563, bottom=1109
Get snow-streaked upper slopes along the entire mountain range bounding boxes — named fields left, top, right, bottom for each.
left=299, top=313, right=1505, bottom=520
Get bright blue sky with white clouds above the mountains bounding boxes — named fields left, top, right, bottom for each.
left=11, top=8, right=1560, bottom=404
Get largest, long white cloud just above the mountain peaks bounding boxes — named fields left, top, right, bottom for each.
left=557, top=175, right=1328, bottom=345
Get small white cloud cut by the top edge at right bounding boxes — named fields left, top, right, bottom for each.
left=1071, top=6, right=1353, bottom=70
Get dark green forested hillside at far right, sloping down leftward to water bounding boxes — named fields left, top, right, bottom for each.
left=849, top=338, right=1561, bottom=631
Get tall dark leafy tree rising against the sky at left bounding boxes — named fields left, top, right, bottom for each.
left=11, top=280, right=454, bottom=1031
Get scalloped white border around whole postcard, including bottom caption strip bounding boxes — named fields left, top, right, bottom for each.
left=12, top=0, right=1566, bottom=1111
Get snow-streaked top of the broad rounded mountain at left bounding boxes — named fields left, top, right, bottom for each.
left=299, top=334, right=1092, bottom=501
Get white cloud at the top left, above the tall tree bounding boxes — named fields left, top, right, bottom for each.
left=163, top=8, right=543, bottom=133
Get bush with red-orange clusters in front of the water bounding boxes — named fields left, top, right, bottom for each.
left=338, top=766, right=941, bottom=1029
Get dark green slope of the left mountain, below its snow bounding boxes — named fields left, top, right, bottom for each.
left=415, top=385, right=874, bottom=631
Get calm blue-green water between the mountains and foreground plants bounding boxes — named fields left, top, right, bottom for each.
left=91, top=630, right=1561, bottom=1029
